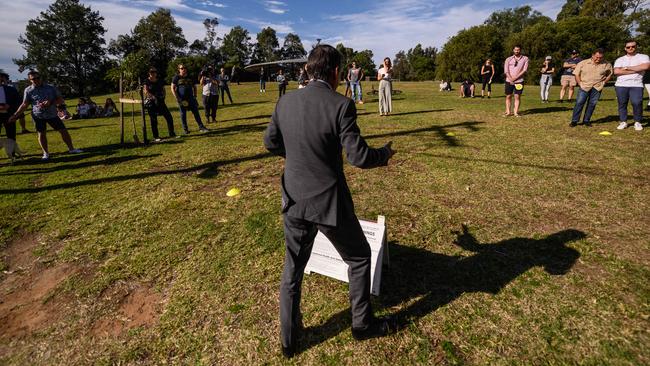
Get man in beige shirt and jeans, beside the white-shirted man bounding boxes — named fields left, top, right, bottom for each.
left=569, top=48, right=612, bottom=127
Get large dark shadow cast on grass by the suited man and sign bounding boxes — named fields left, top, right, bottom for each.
left=299, top=226, right=587, bottom=352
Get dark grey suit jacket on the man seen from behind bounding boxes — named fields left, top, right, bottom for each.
left=264, top=81, right=389, bottom=226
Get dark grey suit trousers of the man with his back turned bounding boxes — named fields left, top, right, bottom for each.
left=280, top=212, right=372, bottom=347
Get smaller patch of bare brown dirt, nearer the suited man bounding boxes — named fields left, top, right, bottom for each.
left=92, top=285, right=163, bottom=337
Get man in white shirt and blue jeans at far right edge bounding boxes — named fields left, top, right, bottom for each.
left=614, top=40, right=650, bottom=131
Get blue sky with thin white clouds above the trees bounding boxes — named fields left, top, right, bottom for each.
left=0, top=0, right=565, bottom=78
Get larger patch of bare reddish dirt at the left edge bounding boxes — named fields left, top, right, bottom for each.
left=0, top=234, right=79, bottom=338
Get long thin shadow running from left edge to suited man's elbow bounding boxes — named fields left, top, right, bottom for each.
left=0, top=152, right=274, bottom=195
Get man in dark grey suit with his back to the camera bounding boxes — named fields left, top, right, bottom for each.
left=264, top=45, right=395, bottom=357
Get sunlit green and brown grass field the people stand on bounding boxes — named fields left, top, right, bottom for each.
left=0, top=82, right=650, bottom=365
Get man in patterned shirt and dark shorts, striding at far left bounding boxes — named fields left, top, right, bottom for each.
left=9, top=70, right=82, bottom=160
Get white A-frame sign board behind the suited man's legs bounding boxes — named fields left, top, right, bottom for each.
left=305, top=216, right=388, bottom=296
